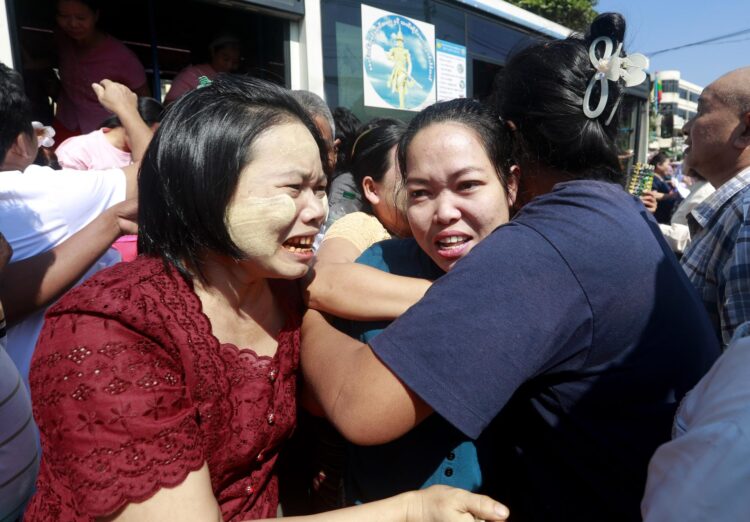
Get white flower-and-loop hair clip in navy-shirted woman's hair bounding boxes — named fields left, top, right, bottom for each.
left=583, top=36, right=649, bottom=125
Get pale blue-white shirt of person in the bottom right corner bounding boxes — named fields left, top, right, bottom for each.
left=641, top=336, right=750, bottom=522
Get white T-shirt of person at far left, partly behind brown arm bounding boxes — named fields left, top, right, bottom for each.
left=0, top=165, right=126, bottom=379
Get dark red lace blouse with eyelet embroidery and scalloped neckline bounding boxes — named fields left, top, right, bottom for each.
left=26, top=257, right=300, bottom=521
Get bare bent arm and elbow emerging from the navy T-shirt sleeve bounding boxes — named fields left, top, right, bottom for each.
left=301, top=310, right=432, bottom=445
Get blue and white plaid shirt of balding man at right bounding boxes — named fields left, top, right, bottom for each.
left=681, top=168, right=750, bottom=346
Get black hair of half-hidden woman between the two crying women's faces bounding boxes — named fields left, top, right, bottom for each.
left=350, top=118, right=406, bottom=190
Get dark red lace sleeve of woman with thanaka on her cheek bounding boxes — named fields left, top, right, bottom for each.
left=30, top=308, right=205, bottom=517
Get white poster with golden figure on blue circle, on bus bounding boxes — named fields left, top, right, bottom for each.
left=362, top=5, right=436, bottom=111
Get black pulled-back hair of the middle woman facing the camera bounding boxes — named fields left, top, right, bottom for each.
left=398, top=98, right=512, bottom=191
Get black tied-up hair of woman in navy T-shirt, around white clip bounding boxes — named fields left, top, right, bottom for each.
left=497, top=13, right=625, bottom=184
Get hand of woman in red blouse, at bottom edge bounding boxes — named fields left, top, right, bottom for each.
left=404, top=486, right=510, bottom=522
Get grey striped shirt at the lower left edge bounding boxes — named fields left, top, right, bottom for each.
left=0, top=316, right=39, bottom=522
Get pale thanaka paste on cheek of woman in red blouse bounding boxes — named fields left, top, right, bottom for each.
left=226, top=194, right=297, bottom=257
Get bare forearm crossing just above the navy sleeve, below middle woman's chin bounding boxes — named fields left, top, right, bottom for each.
left=307, top=263, right=432, bottom=321
